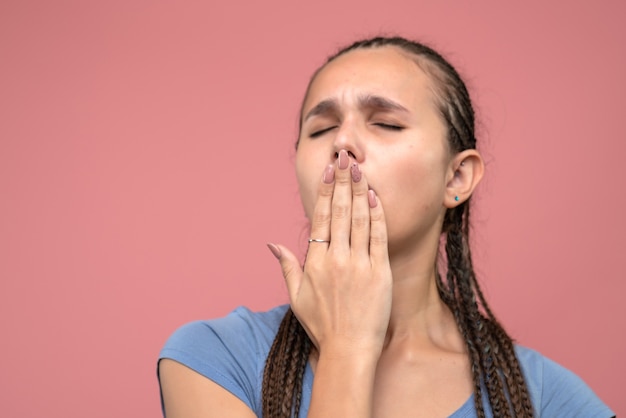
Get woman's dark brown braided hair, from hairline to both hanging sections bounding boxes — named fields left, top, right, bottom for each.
left=262, top=37, right=533, bottom=418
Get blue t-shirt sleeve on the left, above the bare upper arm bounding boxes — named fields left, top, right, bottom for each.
left=159, top=308, right=280, bottom=414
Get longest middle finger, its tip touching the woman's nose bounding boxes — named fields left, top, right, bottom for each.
left=330, top=150, right=352, bottom=252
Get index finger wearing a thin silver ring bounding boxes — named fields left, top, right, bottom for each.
left=307, top=164, right=335, bottom=259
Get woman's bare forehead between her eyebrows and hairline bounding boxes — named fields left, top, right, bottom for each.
left=303, top=46, right=432, bottom=112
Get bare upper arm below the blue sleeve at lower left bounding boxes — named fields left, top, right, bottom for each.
left=159, top=359, right=256, bottom=418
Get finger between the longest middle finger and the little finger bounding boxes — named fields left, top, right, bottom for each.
left=350, top=162, right=370, bottom=257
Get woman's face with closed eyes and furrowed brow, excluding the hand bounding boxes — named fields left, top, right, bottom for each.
left=296, top=47, right=453, bottom=255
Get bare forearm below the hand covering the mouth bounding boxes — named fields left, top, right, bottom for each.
left=308, top=353, right=378, bottom=418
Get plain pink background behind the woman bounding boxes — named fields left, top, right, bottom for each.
left=0, top=0, right=626, bottom=418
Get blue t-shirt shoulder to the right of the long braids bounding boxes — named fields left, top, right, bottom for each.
left=518, top=349, right=615, bottom=418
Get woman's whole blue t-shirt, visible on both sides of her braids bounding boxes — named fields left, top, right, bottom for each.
left=159, top=305, right=615, bottom=418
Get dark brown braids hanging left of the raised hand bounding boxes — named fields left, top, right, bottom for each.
left=262, top=308, right=311, bottom=418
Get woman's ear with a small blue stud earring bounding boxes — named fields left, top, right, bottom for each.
left=444, top=149, right=485, bottom=209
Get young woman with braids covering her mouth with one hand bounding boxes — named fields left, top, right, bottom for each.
left=159, top=38, right=614, bottom=418
